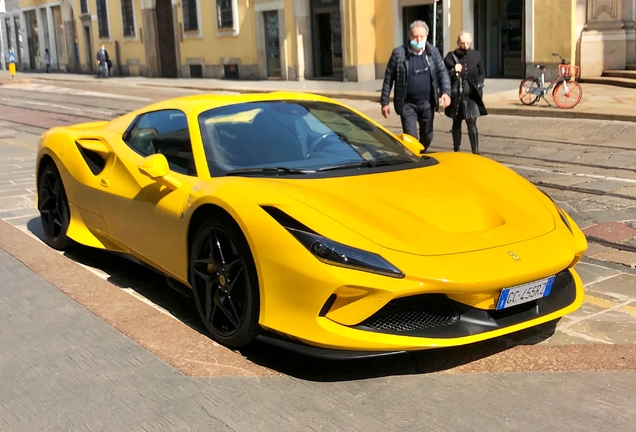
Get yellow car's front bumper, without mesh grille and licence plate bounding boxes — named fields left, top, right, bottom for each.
left=245, top=201, right=586, bottom=352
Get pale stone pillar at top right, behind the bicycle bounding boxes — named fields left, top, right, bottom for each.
left=581, top=0, right=633, bottom=78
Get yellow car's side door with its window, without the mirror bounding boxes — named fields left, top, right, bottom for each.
left=98, top=110, right=199, bottom=277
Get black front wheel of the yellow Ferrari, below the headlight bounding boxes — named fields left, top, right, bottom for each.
left=190, top=216, right=260, bottom=348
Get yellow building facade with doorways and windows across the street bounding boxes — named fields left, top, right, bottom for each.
left=2, top=0, right=636, bottom=81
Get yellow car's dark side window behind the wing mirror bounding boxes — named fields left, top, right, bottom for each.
left=124, top=110, right=196, bottom=176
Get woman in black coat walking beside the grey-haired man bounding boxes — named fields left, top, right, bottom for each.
left=444, top=32, right=488, bottom=154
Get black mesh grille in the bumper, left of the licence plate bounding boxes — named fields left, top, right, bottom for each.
left=360, top=294, right=459, bottom=332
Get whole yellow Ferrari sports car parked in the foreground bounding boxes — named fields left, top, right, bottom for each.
left=37, top=93, right=587, bottom=358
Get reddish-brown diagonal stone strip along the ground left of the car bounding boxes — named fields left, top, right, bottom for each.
left=0, top=221, right=272, bottom=376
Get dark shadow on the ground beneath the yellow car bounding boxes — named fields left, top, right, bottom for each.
left=27, top=218, right=556, bottom=382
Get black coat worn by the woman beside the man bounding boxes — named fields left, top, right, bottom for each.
left=444, top=50, right=488, bottom=118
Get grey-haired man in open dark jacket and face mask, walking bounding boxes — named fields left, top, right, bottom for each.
left=380, top=21, right=451, bottom=151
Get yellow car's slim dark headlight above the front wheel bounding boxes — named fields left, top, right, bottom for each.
left=285, top=227, right=404, bottom=278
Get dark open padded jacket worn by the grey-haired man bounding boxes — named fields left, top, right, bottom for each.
left=380, top=42, right=450, bottom=115
